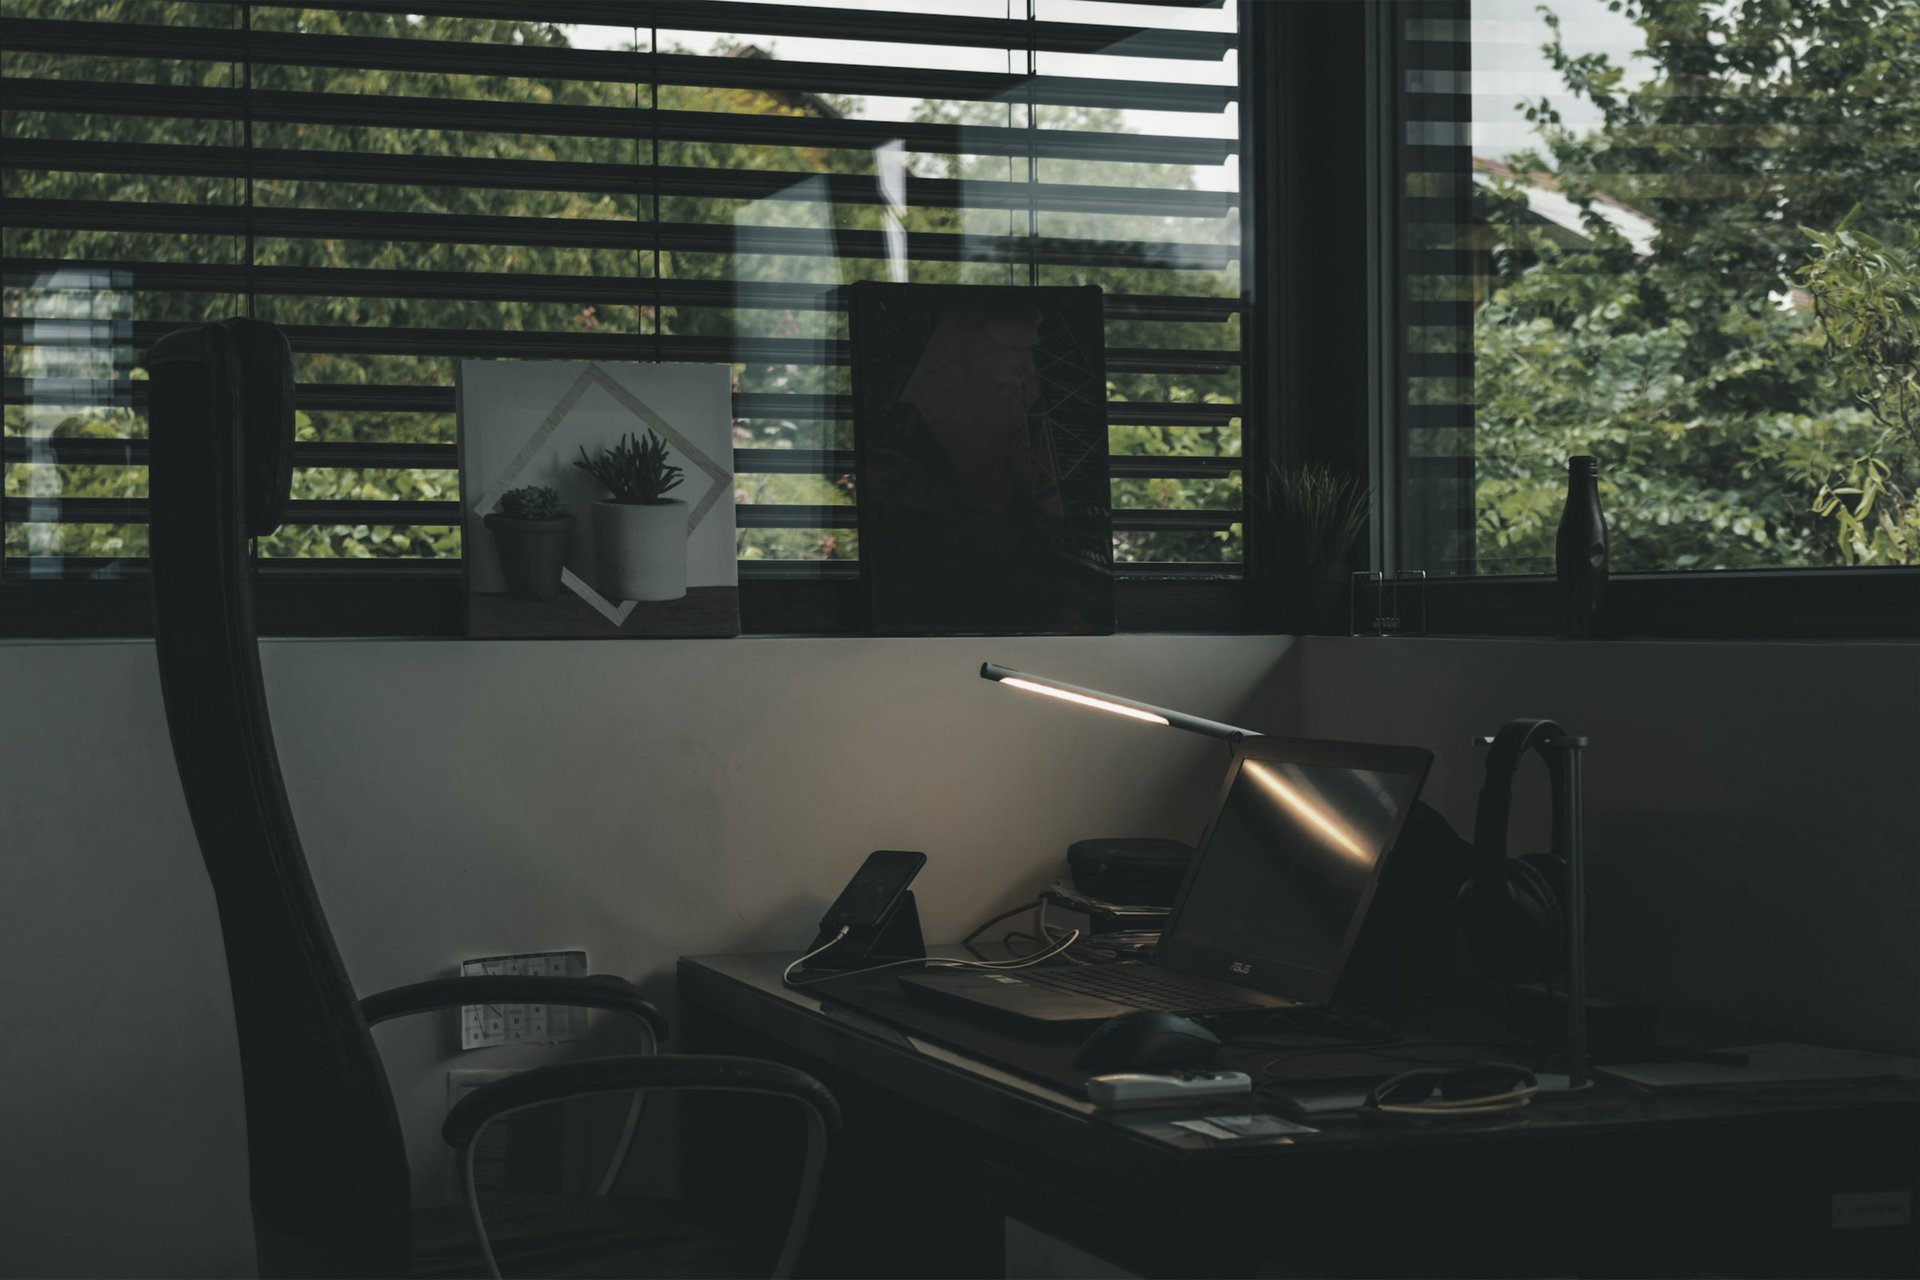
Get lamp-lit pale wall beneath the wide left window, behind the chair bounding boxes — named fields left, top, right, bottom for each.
left=0, top=637, right=1290, bottom=1274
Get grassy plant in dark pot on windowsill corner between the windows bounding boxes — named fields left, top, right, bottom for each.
left=1267, top=462, right=1371, bottom=635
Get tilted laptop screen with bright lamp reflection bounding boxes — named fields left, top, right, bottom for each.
left=1156, top=739, right=1430, bottom=1002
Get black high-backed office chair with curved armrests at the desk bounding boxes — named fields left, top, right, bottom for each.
left=148, top=320, right=839, bottom=1276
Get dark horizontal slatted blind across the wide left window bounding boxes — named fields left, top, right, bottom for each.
left=0, top=0, right=1244, bottom=580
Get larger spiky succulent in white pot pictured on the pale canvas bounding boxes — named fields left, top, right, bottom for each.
left=574, top=430, right=687, bottom=601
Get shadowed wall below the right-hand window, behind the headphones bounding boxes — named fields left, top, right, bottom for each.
left=1292, top=637, right=1920, bottom=1054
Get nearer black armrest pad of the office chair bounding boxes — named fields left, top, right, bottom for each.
left=440, top=1054, right=841, bottom=1151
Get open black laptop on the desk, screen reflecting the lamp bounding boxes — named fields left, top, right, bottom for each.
left=899, top=737, right=1432, bottom=1023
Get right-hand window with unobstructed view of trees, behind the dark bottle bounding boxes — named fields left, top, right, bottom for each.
left=1394, top=0, right=1920, bottom=629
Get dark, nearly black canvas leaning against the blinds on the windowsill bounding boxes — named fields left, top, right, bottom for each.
left=849, top=282, right=1114, bottom=635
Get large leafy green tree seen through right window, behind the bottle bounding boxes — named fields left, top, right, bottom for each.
left=1474, top=0, right=1920, bottom=572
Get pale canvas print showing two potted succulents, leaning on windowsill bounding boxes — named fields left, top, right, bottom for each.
left=459, top=361, right=739, bottom=639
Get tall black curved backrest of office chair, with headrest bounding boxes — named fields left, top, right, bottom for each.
left=146, top=320, right=411, bottom=1276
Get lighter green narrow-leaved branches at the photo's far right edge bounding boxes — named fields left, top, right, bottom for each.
left=1799, top=198, right=1920, bottom=564
